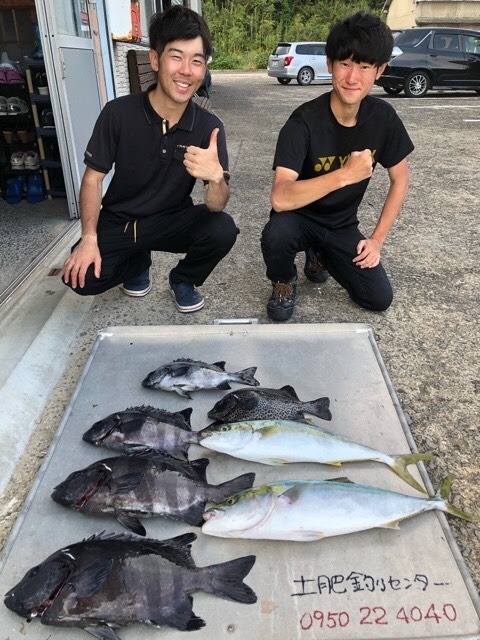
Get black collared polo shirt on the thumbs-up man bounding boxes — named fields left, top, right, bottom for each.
left=84, top=85, right=228, bottom=218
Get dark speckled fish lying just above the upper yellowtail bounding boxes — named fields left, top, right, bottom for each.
left=208, top=385, right=332, bottom=422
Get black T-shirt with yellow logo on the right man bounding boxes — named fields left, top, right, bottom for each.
left=273, top=93, right=413, bottom=229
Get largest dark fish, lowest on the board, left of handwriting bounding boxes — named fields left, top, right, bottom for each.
left=5, top=533, right=257, bottom=640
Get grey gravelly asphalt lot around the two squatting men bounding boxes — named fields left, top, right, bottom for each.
left=0, top=67, right=480, bottom=588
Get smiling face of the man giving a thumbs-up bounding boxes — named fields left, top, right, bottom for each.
left=150, top=36, right=207, bottom=104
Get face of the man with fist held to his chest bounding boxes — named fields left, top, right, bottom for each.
left=327, top=58, right=386, bottom=108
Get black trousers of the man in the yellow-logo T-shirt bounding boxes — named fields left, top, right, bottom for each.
left=261, top=211, right=393, bottom=311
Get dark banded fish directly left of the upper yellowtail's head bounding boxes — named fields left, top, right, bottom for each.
left=83, top=406, right=199, bottom=458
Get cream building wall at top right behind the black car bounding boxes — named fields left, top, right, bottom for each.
left=387, top=0, right=480, bottom=30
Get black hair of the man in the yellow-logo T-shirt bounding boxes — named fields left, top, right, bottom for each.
left=325, top=11, right=393, bottom=67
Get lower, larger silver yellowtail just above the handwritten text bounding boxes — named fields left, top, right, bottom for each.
left=202, top=476, right=480, bottom=542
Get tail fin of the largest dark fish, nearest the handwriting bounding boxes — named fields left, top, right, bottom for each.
left=201, top=556, right=257, bottom=604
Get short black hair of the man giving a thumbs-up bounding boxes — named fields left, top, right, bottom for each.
left=148, top=5, right=212, bottom=59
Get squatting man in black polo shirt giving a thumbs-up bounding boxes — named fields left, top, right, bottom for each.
left=63, top=6, right=238, bottom=313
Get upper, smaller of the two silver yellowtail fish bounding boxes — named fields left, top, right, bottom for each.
left=198, top=420, right=434, bottom=493
